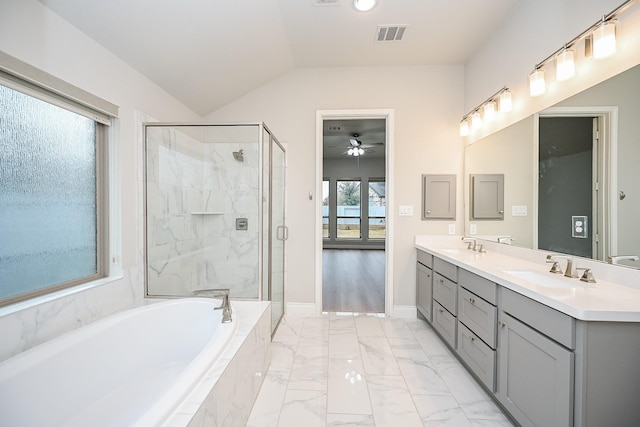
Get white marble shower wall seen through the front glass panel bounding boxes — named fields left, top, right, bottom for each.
left=146, top=126, right=260, bottom=298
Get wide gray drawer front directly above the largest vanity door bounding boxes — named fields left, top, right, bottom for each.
left=500, top=287, right=576, bottom=349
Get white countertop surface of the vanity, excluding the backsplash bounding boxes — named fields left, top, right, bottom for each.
left=416, top=243, right=640, bottom=322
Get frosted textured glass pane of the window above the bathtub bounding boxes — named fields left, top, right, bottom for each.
left=0, top=86, right=102, bottom=302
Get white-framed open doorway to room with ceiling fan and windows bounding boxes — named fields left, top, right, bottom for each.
left=316, top=110, right=393, bottom=314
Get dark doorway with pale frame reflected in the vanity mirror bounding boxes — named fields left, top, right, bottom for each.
left=535, top=107, right=617, bottom=260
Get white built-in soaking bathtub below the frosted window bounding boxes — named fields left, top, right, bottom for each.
left=0, top=298, right=264, bottom=427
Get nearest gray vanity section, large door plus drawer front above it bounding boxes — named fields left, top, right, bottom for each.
left=496, top=288, right=575, bottom=427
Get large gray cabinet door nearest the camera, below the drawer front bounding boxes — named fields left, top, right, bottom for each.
left=496, top=312, right=574, bottom=427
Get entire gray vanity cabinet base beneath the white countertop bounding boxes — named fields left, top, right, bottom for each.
left=417, top=246, right=640, bottom=427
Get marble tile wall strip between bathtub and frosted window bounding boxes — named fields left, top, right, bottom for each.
left=0, top=268, right=143, bottom=361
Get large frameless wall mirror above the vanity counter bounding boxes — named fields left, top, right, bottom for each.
left=465, top=65, right=640, bottom=268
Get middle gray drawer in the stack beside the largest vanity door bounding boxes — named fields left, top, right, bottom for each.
left=458, top=288, right=498, bottom=348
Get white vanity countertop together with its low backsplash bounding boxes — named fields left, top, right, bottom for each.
left=415, top=236, right=640, bottom=322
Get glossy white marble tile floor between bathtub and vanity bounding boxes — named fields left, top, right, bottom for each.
left=247, top=313, right=512, bottom=427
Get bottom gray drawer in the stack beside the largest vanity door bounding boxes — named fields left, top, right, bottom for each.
left=457, top=324, right=496, bottom=392
